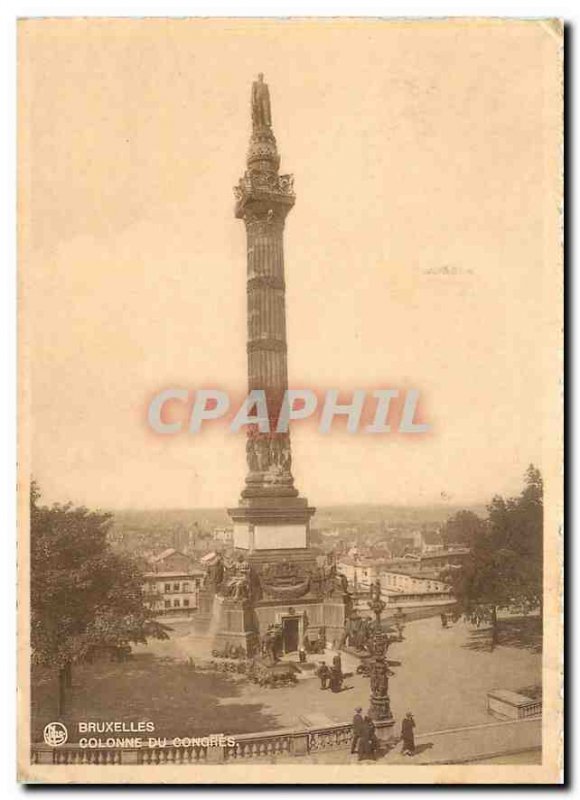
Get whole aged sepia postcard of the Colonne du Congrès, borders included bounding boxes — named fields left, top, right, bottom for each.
left=18, top=18, right=563, bottom=784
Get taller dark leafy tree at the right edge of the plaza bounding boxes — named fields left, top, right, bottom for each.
left=452, top=465, right=543, bottom=648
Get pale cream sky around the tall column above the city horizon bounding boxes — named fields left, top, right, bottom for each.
left=19, top=19, right=560, bottom=508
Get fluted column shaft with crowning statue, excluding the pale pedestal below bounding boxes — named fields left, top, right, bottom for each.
left=235, top=81, right=298, bottom=497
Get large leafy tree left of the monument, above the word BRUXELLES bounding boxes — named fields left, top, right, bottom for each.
left=30, top=482, right=167, bottom=715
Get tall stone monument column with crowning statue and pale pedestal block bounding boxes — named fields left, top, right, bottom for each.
left=228, top=76, right=316, bottom=552
